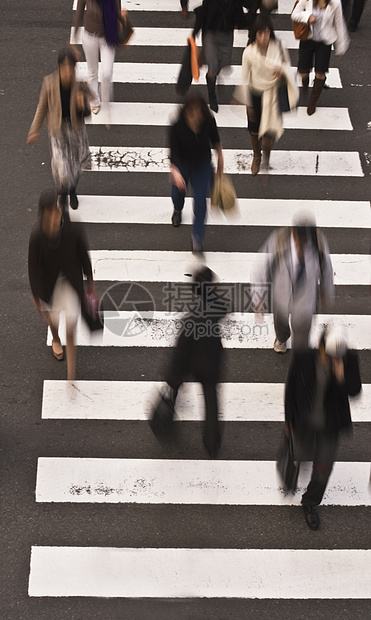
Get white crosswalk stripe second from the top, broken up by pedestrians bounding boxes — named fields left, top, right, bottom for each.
left=70, top=27, right=299, bottom=49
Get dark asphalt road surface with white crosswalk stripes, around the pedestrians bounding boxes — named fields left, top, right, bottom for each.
left=0, top=0, right=371, bottom=620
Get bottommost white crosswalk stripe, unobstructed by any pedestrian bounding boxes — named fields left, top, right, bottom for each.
left=29, top=546, right=371, bottom=599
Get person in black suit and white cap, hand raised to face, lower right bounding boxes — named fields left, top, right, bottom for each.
left=285, top=326, right=361, bottom=530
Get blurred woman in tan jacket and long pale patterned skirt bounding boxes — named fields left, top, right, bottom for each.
left=27, top=49, right=91, bottom=209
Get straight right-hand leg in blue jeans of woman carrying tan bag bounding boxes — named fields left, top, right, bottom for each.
left=190, top=162, right=212, bottom=251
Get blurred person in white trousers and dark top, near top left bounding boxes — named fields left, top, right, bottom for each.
left=74, top=0, right=121, bottom=114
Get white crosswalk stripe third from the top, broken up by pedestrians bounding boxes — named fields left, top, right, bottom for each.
left=76, top=62, right=342, bottom=88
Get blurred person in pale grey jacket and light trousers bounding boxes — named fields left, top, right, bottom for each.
left=253, top=212, right=334, bottom=353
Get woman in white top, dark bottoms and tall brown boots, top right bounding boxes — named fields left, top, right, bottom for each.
left=291, top=0, right=349, bottom=116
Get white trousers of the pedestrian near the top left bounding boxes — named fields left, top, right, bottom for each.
left=82, top=30, right=116, bottom=106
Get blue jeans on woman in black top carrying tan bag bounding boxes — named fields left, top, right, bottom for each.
left=171, top=161, right=214, bottom=243
